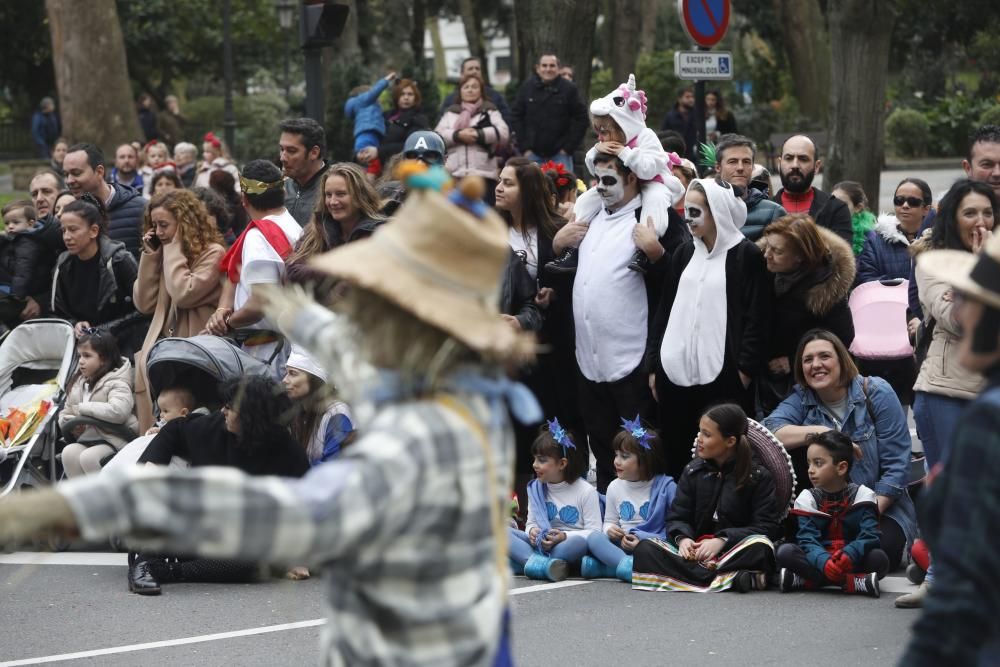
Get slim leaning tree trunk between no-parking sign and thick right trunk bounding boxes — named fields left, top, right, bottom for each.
left=774, top=0, right=841, bottom=124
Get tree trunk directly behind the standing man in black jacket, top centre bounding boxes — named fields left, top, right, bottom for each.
left=514, top=0, right=599, bottom=100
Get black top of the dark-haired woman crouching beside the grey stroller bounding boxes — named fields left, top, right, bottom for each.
left=139, top=412, right=309, bottom=477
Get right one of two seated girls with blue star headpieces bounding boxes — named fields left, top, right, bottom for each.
left=580, top=415, right=677, bottom=583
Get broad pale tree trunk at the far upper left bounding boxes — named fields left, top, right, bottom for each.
left=45, top=0, right=142, bottom=155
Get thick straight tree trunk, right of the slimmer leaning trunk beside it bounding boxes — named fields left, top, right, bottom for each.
left=823, top=0, right=897, bottom=207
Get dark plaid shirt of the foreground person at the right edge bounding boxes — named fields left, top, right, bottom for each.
left=899, top=371, right=1000, bottom=666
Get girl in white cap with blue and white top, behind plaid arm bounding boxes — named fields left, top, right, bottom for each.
left=282, top=346, right=355, bottom=465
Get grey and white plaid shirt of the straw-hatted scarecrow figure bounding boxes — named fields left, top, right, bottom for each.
left=58, top=395, right=513, bottom=666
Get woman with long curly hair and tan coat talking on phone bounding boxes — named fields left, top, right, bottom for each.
left=133, top=190, right=225, bottom=432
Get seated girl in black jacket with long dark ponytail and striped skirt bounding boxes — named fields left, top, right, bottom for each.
left=632, top=403, right=779, bottom=593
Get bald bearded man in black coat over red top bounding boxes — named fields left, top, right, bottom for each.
left=774, top=134, right=854, bottom=244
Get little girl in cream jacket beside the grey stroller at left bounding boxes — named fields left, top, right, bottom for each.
left=59, top=329, right=139, bottom=477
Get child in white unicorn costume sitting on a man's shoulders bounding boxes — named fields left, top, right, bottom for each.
left=545, top=74, right=684, bottom=273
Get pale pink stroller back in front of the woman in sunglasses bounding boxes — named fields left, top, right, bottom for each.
left=848, top=279, right=913, bottom=360
